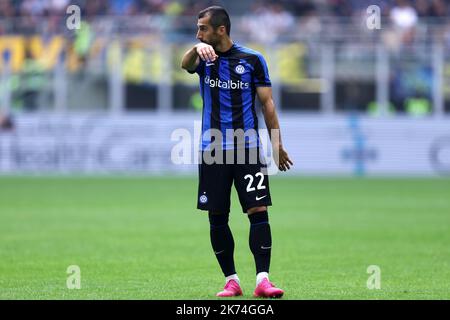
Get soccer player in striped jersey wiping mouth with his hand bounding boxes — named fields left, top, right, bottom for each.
left=181, top=6, right=293, bottom=298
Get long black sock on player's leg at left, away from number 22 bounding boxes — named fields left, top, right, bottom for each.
left=209, top=212, right=236, bottom=277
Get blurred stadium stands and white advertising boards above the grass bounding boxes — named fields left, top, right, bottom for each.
left=0, top=0, right=450, bottom=176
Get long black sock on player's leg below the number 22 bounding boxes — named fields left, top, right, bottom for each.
left=248, top=211, right=272, bottom=274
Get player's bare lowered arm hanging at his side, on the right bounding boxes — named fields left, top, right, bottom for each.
left=256, top=87, right=294, bottom=171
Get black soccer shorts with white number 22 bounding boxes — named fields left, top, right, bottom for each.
left=197, top=149, right=272, bottom=213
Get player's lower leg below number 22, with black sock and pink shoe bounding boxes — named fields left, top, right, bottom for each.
left=247, top=206, right=284, bottom=298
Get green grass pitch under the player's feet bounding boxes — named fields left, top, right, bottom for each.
left=0, top=176, right=450, bottom=300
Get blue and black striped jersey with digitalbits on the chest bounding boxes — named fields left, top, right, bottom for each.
left=192, top=43, right=271, bottom=150
